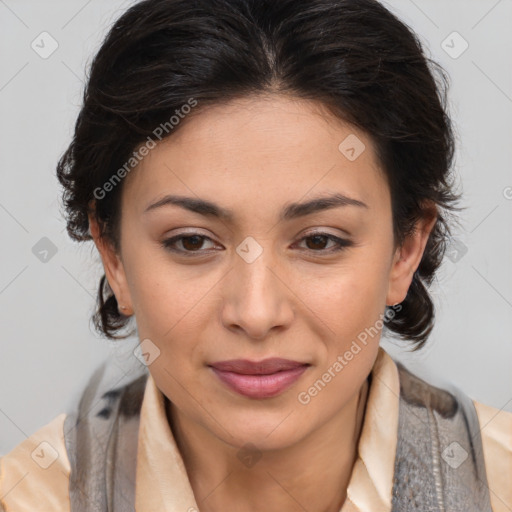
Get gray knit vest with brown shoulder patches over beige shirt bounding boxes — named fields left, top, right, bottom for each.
left=64, top=362, right=492, bottom=512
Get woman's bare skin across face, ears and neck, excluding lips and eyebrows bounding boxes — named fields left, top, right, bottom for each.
left=90, top=96, right=435, bottom=512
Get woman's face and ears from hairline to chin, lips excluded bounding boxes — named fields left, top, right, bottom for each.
left=91, top=96, right=432, bottom=449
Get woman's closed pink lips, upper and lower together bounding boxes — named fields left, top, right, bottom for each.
left=209, top=357, right=310, bottom=398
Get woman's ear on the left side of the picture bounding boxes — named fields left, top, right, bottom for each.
left=89, top=209, right=133, bottom=316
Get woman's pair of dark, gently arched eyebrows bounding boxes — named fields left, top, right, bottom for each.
left=144, top=194, right=368, bottom=222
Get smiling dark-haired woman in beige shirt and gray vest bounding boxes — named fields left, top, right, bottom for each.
left=0, top=0, right=512, bottom=512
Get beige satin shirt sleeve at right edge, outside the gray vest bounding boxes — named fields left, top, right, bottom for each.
left=473, top=400, right=512, bottom=512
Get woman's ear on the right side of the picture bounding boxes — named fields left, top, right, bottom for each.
left=386, top=203, right=437, bottom=306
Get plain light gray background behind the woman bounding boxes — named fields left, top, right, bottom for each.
left=0, top=0, right=512, bottom=454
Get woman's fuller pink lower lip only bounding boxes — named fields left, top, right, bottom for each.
left=211, top=365, right=307, bottom=398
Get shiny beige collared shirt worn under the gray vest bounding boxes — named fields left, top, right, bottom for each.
left=0, top=348, right=512, bottom=512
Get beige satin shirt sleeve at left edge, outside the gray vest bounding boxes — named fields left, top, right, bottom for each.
left=0, top=413, right=70, bottom=512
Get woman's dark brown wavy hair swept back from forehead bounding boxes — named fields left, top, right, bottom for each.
left=57, top=0, right=459, bottom=350
